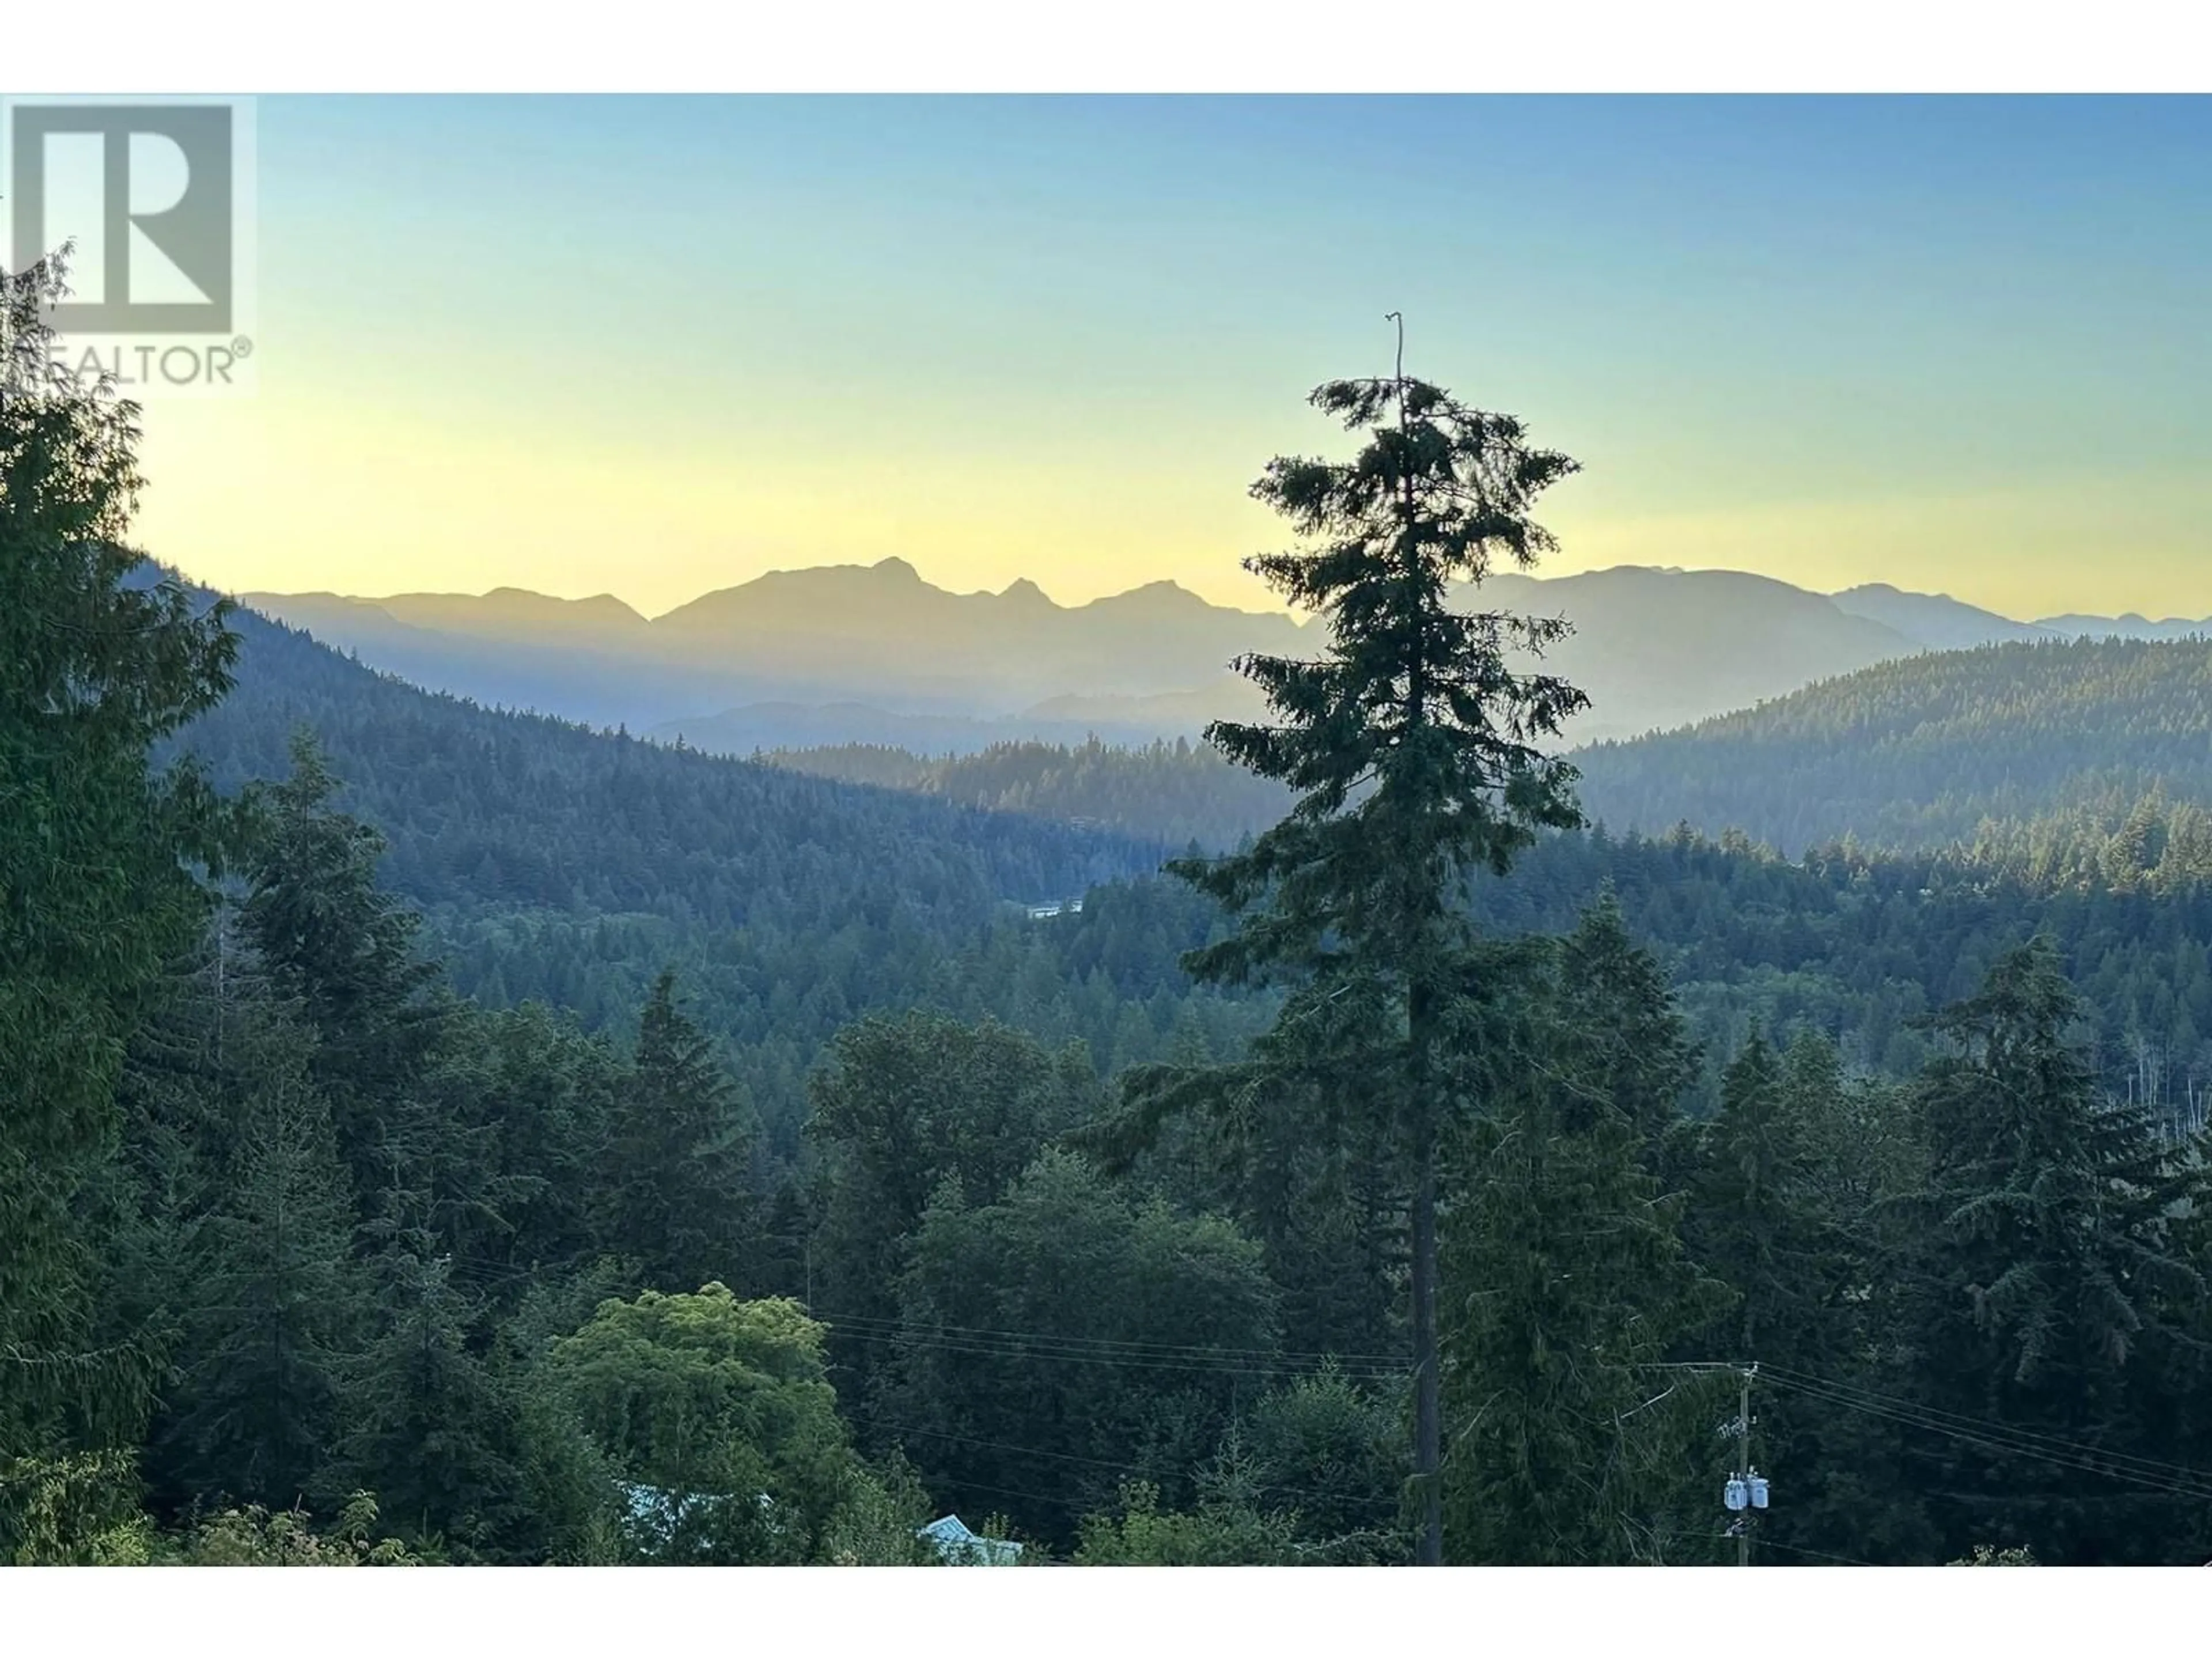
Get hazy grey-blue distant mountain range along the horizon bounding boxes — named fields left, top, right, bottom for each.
left=239, top=560, right=2212, bottom=754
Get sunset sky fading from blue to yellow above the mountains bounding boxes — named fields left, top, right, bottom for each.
left=99, top=97, right=2212, bottom=617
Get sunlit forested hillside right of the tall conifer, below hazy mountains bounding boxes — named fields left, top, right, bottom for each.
left=1575, top=639, right=2212, bottom=854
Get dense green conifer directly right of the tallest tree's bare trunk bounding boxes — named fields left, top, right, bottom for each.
left=1440, top=925, right=1730, bottom=1564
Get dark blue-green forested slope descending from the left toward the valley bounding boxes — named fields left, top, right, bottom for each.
left=179, top=611, right=1157, bottom=929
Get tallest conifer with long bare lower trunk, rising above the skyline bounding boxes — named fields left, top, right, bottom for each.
left=1141, top=345, right=1586, bottom=1564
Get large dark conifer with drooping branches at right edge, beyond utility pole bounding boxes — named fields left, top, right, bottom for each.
left=1911, top=938, right=2207, bottom=1564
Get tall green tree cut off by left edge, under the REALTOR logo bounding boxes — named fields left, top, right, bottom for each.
left=0, top=263, right=232, bottom=1553
